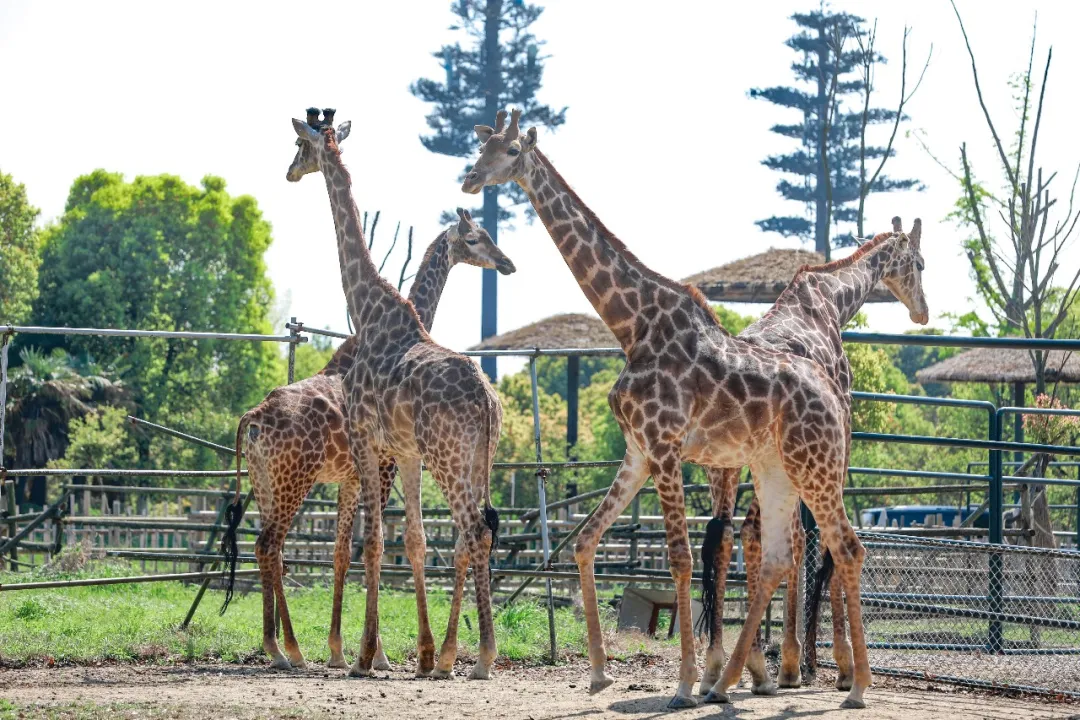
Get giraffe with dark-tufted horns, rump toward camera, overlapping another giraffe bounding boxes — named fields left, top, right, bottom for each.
left=287, top=110, right=502, bottom=679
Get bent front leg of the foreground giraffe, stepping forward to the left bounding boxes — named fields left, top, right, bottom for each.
left=573, top=445, right=649, bottom=694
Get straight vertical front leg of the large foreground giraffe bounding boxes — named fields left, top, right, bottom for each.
left=649, top=453, right=698, bottom=709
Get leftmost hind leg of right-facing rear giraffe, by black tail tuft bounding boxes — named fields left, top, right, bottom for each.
left=698, top=467, right=739, bottom=695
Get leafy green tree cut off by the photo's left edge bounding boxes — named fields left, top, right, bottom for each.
left=0, top=173, right=41, bottom=325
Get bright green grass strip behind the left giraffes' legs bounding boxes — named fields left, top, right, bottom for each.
left=0, top=561, right=615, bottom=669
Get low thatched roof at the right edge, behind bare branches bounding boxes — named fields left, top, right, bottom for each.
left=915, top=348, right=1080, bottom=382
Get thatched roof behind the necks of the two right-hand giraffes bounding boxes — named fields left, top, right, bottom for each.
left=683, top=247, right=896, bottom=302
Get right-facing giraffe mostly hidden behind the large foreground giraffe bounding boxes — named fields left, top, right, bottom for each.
left=701, top=217, right=929, bottom=695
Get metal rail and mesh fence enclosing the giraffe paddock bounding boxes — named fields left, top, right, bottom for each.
left=0, top=318, right=1080, bottom=693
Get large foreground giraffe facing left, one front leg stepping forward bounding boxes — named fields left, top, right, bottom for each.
left=462, top=110, right=870, bottom=708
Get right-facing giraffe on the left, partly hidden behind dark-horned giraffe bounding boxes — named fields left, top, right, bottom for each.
left=222, top=201, right=516, bottom=669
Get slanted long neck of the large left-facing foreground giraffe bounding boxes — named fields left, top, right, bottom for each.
left=515, top=150, right=716, bottom=352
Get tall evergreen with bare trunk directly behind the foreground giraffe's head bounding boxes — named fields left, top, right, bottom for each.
left=409, top=0, right=566, bottom=379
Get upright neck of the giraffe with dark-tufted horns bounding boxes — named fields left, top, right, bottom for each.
left=319, top=144, right=424, bottom=343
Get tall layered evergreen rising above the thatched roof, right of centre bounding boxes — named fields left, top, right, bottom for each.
left=750, top=3, right=920, bottom=257
